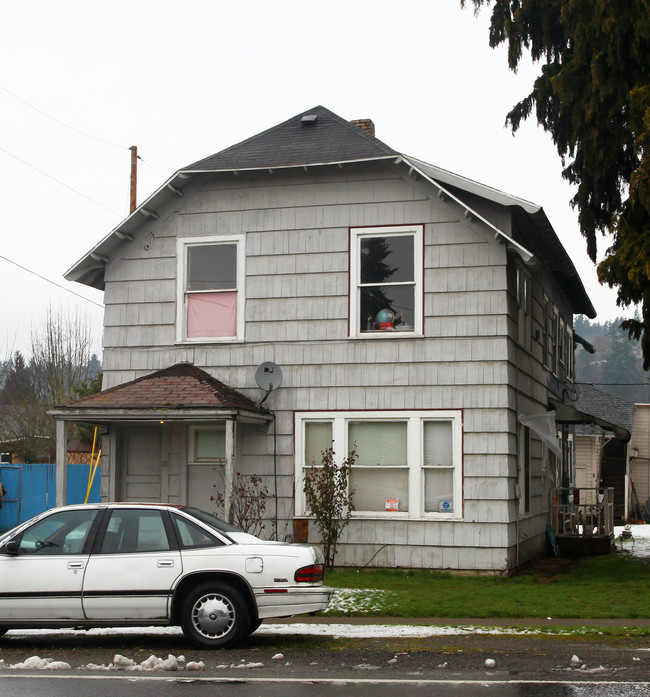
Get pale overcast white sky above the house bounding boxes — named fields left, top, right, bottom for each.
left=0, top=0, right=629, bottom=358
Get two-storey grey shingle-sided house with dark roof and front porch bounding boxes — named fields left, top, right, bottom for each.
left=52, top=107, right=595, bottom=573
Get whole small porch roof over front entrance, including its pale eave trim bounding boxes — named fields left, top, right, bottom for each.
left=49, top=363, right=272, bottom=421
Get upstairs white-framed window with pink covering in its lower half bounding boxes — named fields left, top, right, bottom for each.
left=176, top=235, right=245, bottom=341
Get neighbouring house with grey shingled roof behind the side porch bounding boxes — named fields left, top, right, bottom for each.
left=573, top=383, right=634, bottom=522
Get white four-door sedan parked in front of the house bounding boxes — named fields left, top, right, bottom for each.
left=0, top=503, right=332, bottom=648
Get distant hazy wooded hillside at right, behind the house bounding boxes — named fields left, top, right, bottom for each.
left=574, top=315, right=650, bottom=403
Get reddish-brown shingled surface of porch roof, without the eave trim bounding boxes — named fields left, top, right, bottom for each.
left=66, top=363, right=262, bottom=412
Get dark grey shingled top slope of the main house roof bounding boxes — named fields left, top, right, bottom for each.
left=182, top=106, right=399, bottom=172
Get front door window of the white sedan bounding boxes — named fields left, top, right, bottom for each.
left=18, top=509, right=98, bottom=554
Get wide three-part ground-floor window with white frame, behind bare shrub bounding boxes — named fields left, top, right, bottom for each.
left=295, top=410, right=462, bottom=518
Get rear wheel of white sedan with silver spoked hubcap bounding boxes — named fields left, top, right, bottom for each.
left=181, top=583, right=250, bottom=649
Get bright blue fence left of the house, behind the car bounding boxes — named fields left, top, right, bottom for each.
left=0, top=464, right=101, bottom=532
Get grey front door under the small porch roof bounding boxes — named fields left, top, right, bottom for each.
left=120, top=424, right=163, bottom=502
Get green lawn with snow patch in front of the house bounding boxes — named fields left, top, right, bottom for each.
left=325, top=554, right=650, bottom=619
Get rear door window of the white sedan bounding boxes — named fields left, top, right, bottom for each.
left=100, top=508, right=171, bottom=554
